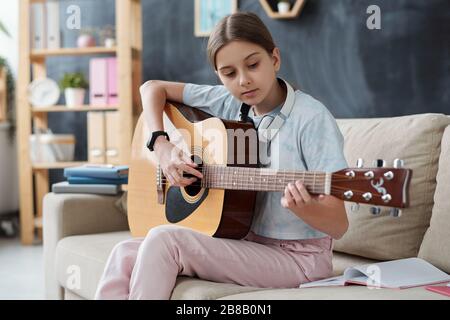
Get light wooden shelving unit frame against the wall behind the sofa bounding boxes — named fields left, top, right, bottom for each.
left=17, top=0, right=142, bottom=245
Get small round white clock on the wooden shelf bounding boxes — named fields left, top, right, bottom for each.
left=28, top=78, right=61, bottom=107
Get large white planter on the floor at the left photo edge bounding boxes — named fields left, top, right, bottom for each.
left=0, top=122, right=19, bottom=216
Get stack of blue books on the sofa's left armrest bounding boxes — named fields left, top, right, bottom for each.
left=52, top=165, right=128, bottom=195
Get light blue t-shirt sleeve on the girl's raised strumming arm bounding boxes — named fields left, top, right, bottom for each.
left=183, top=83, right=240, bottom=119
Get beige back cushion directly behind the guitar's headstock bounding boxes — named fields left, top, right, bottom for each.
left=334, top=114, right=450, bottom=260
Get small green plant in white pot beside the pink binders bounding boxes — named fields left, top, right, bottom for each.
left=59, top=72, right=88, bottom=107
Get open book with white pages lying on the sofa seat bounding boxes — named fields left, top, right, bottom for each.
left=300, top=258, right=450, bottom=289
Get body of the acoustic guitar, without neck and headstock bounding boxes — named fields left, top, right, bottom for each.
left=128, top=103, right=258, bottom=239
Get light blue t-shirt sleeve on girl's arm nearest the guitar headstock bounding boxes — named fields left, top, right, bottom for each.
left=300, top=111, right=348, bottom=172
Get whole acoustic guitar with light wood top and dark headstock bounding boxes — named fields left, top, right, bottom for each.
left=128, top=103, right=412, bottom=239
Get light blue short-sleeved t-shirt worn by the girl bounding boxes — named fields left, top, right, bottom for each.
left=183, top=83, right=348, bottom=240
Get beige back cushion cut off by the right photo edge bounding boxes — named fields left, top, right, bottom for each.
left=419, top=126, right=450, bottom=273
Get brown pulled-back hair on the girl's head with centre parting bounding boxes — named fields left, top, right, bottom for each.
left=207, top=12, right=276, bottom=70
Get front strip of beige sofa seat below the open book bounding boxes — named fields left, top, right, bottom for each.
left=219, top=286, right=450, bottom=300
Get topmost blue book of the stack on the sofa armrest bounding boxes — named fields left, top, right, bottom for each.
left=64, top=165, right=128, bottom=179
